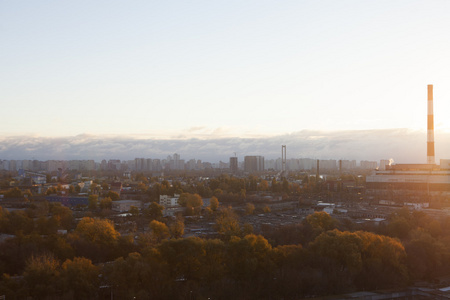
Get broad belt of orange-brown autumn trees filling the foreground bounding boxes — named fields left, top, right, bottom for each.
left=0, top=204, right=450, bottom=299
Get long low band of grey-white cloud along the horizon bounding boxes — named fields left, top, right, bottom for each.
left=0, top=128, right=450, bottom=163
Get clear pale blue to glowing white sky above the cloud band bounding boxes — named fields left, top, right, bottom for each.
left=0, top=0, right=450, bottom=159
